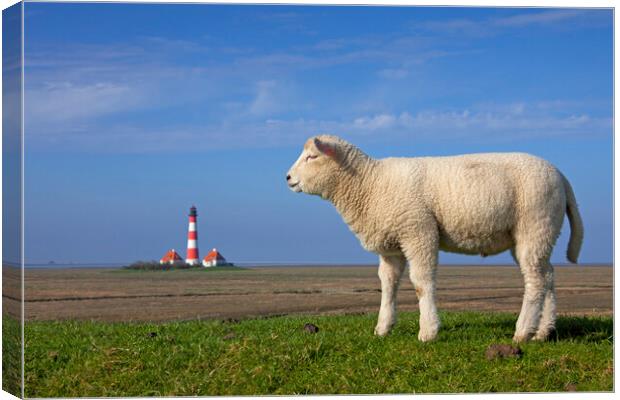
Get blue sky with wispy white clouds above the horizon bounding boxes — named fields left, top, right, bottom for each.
left=25, top=3, right=613, bottom=264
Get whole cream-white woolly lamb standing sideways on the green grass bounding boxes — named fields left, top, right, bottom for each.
left=286, top=135, right=583, bottom=342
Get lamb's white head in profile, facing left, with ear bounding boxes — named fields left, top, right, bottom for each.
left=286, top=135, right=367, bottom=198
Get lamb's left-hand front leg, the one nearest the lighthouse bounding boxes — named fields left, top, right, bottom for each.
left=375, top=256, right=406, bottom=336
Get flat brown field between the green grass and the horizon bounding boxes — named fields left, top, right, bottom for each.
left=3, top=266, right=613, bottom=321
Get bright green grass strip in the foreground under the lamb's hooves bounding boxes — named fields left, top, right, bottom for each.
left=25, top=313, right=613, bottom=397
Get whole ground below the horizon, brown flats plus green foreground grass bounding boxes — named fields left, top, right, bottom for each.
left=8, top=265, right=613, bottom=397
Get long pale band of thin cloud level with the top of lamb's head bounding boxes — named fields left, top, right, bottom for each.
left=26, top=102, right=613, bottom=153
